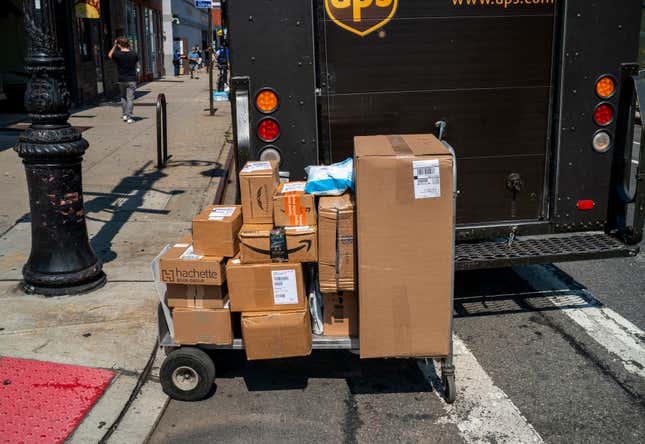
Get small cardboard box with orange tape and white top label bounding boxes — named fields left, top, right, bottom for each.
left=273, top=182, right=316, bottom=227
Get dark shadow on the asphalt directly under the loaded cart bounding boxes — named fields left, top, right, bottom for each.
left=213, top=350, right=433, bottom=394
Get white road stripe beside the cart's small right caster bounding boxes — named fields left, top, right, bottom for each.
left=418, top=335, right=544, bottom=443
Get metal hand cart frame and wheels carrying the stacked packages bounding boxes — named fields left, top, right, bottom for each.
left=152, top=127, right=457, bottom=403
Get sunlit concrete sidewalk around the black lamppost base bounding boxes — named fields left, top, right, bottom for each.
left=0, top=75, right=230, bottom=442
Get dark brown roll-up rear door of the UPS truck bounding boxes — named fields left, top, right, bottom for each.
left=316, top=0, right=556, bottom=224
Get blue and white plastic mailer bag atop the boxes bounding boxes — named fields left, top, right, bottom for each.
left=305, top=157, right=354, bottom=196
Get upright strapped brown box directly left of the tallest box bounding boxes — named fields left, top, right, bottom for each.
left=318, top=193, right=356, bottom=293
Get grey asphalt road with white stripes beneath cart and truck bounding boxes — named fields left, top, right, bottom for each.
left=150, top=136, right=645, bottom=444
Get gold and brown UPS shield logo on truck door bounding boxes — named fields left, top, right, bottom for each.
left=325, top=0, right=399, bottom=37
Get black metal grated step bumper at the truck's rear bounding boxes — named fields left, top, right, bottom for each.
left=455, top=233, right=638, bottom=271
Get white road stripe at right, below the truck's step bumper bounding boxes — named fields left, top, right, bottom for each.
left=516, top=268, right=645, bottom=378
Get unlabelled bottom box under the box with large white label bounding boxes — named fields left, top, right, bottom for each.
left=242, top=309, right=311, bottom=360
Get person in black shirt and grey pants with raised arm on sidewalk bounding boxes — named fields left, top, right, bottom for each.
left=108, top=37, right=139, bottom=123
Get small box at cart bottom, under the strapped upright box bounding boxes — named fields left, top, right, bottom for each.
left=323, top=291, right=358, bottom=336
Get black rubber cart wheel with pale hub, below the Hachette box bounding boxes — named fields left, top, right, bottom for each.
left=159, top=347, right=215, bottom=401
